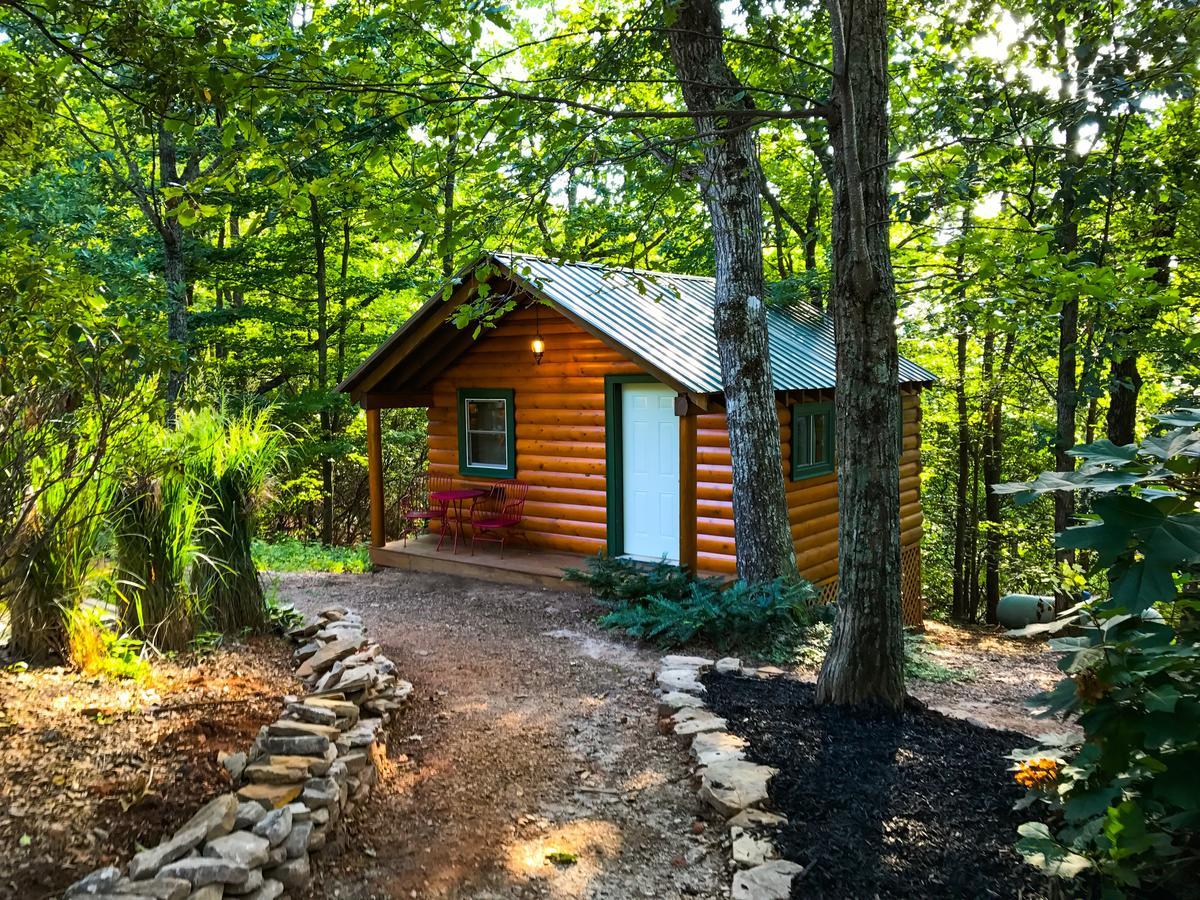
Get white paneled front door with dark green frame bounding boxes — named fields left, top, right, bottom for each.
left=620, top=384, right=679, bottom=562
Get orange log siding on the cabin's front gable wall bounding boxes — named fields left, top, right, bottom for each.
left=430, top=307, right=640, bottom=554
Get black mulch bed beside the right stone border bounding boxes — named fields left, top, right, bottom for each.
left=704, top=673, right=1048, bottom=900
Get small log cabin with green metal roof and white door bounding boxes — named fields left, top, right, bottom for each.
left=338, top=253, right=934, bottom=625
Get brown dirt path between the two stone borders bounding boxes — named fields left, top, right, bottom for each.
left=280, top=571, right=728, bottom=900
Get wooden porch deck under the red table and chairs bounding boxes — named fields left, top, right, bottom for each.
left=371, top=534, right=587, bottom=590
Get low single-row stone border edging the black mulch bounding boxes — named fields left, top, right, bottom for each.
left=656, top=655, right=803, bottom=900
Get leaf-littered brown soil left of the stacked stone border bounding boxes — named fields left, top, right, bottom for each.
left=0, top=638, right=299, bottom=900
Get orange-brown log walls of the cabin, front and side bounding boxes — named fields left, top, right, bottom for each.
left=430, top=308, right=923, bottom=608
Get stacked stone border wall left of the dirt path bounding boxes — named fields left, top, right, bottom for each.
left=64, top=606, right=413, bottom=900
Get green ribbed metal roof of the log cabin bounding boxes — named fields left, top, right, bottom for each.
left=491, top=253, right=935, bottom=394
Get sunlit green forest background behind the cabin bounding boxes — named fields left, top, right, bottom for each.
left=0, top=0, right=1200, bottom=620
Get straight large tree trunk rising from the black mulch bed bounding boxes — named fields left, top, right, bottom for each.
left=817, top=0, right=905, bottom=710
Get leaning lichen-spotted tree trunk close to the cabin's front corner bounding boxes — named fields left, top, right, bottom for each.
left=667, top=0, right=796, bottom=582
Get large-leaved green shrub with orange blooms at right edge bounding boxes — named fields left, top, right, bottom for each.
left=1006, top=409, right=1200, bottom=896
